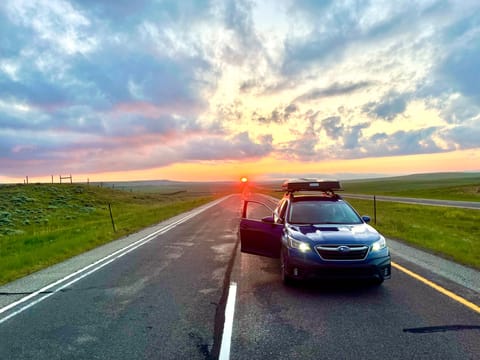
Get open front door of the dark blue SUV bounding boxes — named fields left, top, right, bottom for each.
left=240, top=200, right=283, bottom=258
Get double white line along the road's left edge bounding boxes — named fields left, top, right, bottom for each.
left=0, top=196, right=230, bottom=324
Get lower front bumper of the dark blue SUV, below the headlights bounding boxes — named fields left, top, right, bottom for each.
left=282, top=250, right=391, bottom=281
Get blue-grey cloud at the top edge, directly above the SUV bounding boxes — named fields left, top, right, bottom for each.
left=282, top=1, right=422, bottom=76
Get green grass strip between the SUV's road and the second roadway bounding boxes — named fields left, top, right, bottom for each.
left=347, top=199, right=480, bottom=269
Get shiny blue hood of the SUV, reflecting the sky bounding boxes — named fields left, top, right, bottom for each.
left=287, top=224, right=380, bottom=244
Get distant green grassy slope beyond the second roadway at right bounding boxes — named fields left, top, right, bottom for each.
left=342, top=173, right=480, bottom=201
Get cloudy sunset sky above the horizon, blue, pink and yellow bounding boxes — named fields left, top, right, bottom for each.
left=0, top=0, right=480, bottom=183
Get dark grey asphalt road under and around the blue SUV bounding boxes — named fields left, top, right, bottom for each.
left=0, top=196, right=480, bottom=359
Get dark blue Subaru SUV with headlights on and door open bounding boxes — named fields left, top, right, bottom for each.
left=240, top=179, right=390, bottom=284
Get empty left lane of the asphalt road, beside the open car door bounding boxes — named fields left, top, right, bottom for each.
left=0, top=196, right=241, bottom=359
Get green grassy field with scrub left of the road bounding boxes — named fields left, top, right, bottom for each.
left=0, top=184, right=215, bottom=284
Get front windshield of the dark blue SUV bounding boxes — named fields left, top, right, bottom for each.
left=289, top=200, right=362, bottom=224
